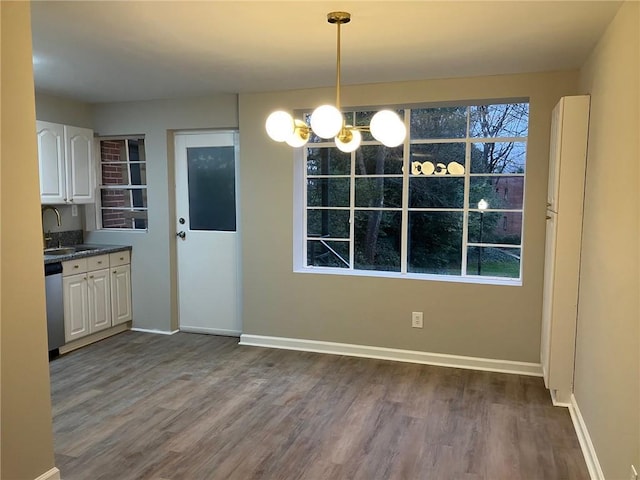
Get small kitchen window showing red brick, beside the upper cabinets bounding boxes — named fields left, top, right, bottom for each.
left=97, top=137, right=147, bottom=230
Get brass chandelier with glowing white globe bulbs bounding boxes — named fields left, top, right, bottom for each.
left=265, top=12, right=407, bottom=152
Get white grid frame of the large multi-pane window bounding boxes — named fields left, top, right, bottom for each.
left=293, top=98, right=531, bottom=286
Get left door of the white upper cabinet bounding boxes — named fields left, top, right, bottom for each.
left=36, top=121, right=67, bottom=204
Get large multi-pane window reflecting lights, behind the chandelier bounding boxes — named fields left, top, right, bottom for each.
left=301, top=103, right=529, bottom=281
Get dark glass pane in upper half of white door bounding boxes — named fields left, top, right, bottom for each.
left=187, top=146, right=236, bottom=232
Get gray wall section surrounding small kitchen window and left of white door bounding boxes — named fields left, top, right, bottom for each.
left=85, top=95, right=238, bottom=331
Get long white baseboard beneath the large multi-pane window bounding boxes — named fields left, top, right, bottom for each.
left=240, top=334, right=542, bottom=377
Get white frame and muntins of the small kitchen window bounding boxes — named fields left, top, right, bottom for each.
left=95, top=135, right=149, bottom=233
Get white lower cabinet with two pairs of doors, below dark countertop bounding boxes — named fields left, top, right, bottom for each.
left=62, top=251, right=132, bottom=343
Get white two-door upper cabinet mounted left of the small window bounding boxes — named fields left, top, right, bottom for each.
left=36, top=121, right=95, bottom=204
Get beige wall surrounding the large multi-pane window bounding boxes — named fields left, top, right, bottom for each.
left=239, top=72, right=578, bottom=363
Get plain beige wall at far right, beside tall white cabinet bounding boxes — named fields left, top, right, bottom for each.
left=574, top=2, right=640, bottom=479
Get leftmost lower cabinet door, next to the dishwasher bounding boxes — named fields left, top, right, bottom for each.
left=62, top=273, right=89, bottom=343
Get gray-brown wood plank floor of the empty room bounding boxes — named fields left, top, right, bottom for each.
left=51, top=332, right=589, bottom=480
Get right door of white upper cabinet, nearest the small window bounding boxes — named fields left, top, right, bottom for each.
left=64, top=125, right=95, bottom=203
